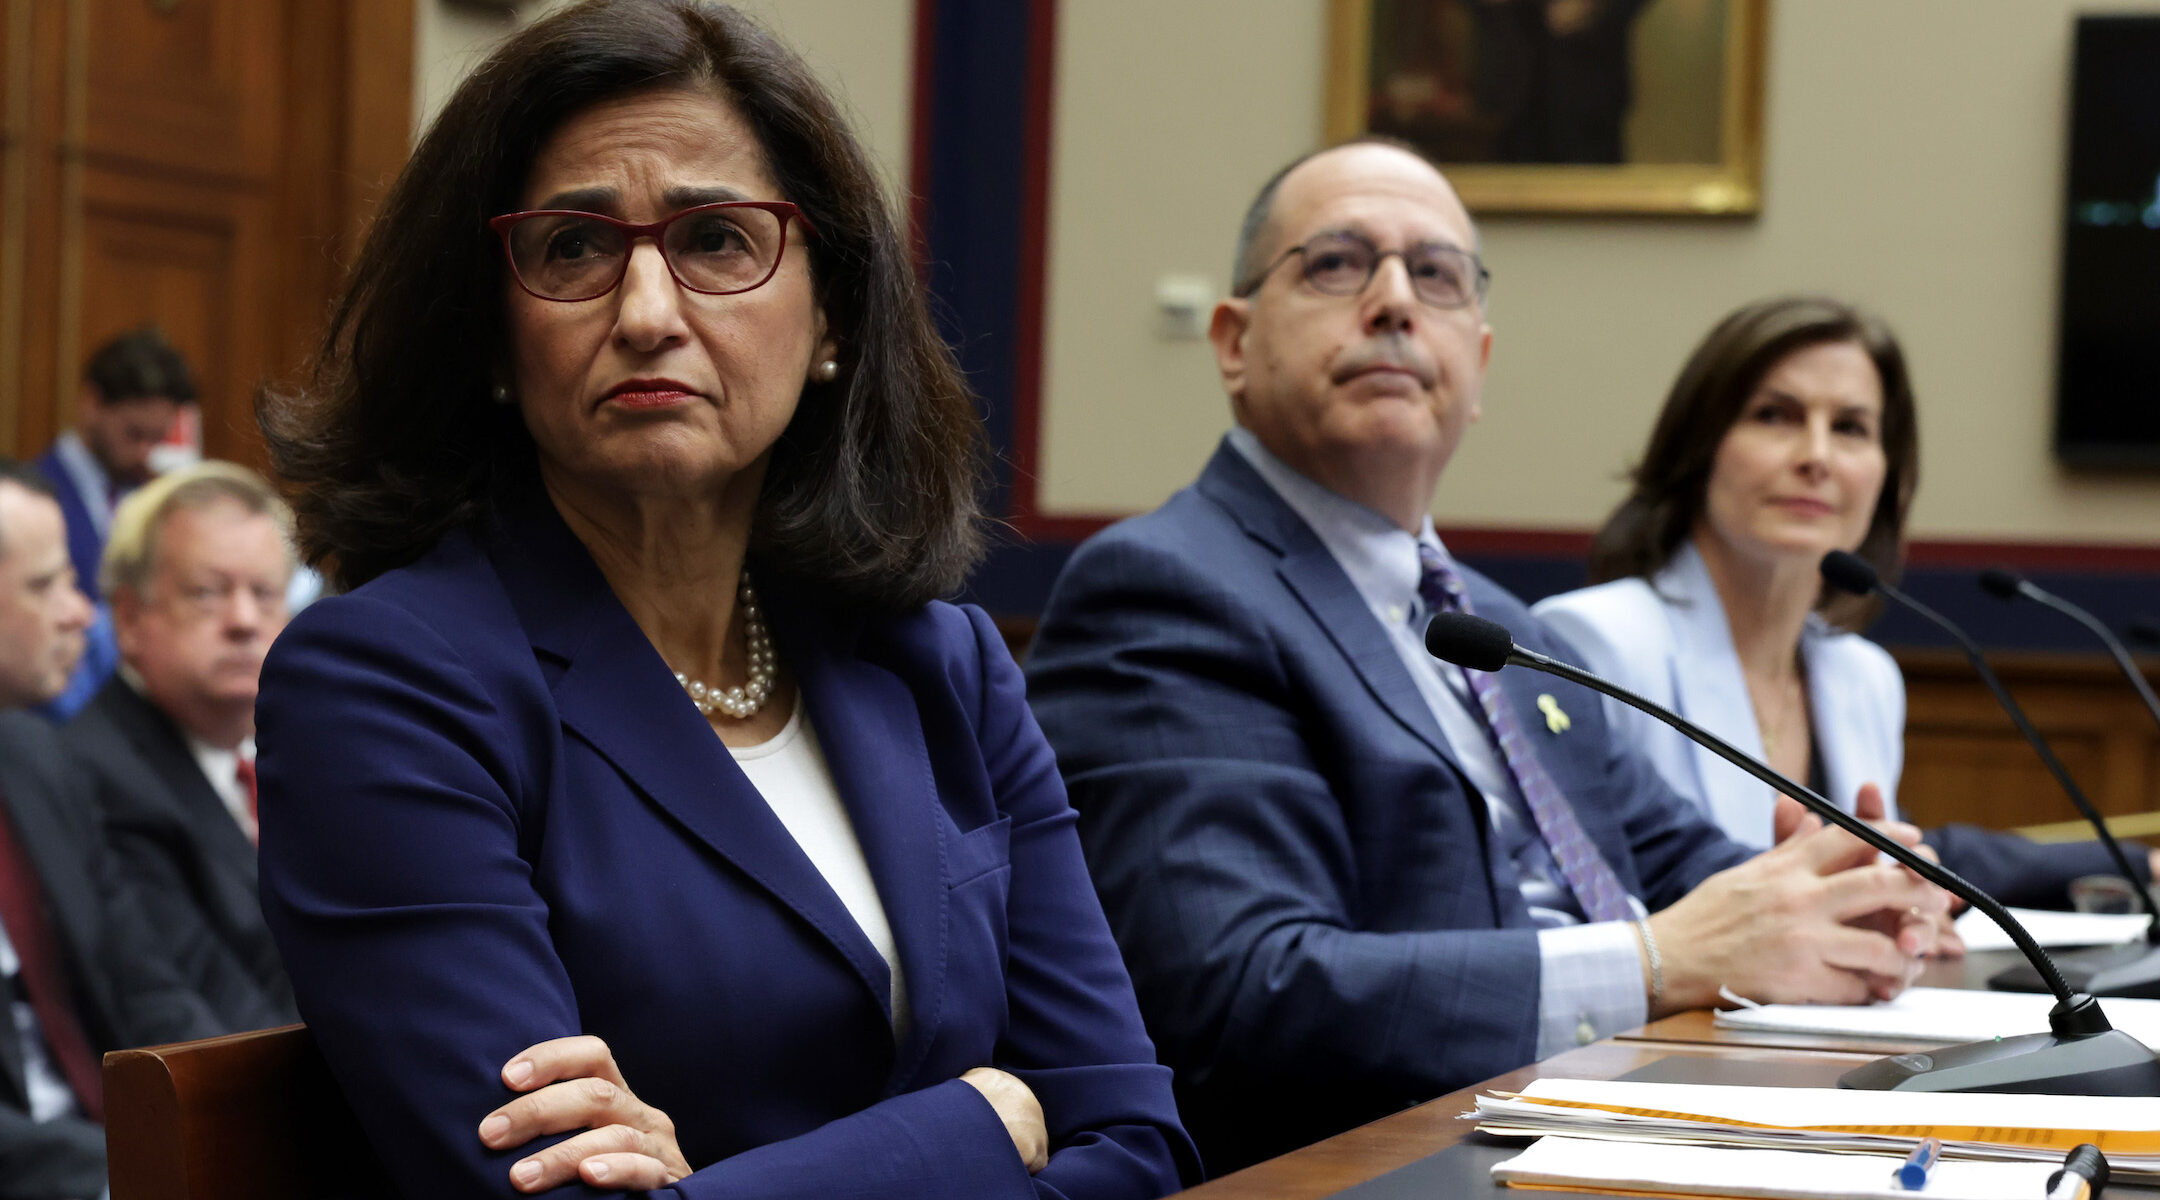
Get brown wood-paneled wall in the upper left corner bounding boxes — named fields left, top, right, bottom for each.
left=0, top=0, right=413, bottom=462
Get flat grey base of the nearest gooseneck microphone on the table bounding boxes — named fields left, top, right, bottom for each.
left=1838, top=1029, right=2160, bottom=1096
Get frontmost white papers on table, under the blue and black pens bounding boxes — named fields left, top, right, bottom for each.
left=1493, top=1137, right=2058, bottom=1200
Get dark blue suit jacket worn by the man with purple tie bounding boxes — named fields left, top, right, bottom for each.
left=1028, top=445, right=1747, bottom=1172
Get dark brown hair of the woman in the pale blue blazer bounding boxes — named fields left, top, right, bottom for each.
left=1590, top=296, right=1920, bottom=630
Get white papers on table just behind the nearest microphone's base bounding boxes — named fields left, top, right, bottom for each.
left=1717, top=988, right=2160, bottom=1049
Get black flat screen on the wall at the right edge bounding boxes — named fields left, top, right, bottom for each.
left=2054, top=15, right=2160, bottom=468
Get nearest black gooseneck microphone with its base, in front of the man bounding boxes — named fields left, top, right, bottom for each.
left=1426, top=613, right=2160, bottom=1096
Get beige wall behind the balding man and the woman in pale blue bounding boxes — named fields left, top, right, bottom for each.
left=1041, top=0, right=2160, bottom=542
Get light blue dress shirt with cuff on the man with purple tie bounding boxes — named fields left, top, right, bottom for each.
left=1229, top=427, right=1648, bottom=1058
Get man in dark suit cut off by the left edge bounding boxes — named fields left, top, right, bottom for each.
left=0, top=460, right=225, bottom=1200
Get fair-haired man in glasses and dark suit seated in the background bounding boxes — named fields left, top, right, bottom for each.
left=60, top=462, right=298, bottom=1029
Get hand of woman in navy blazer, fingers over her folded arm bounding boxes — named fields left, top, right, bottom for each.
left=480, top=1036, right=691, bottom=1191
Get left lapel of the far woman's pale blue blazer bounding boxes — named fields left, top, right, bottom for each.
left=1650, top=544, right=1776, bottom=846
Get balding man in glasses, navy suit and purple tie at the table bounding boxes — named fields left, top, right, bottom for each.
left=1028, top=142, right=1946, bottom=1172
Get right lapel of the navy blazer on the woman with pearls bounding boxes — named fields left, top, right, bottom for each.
left=767, top=602, right=953, bottom=1090
